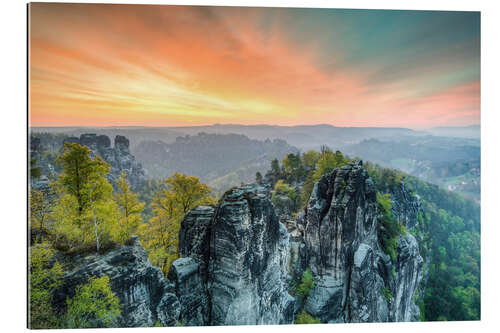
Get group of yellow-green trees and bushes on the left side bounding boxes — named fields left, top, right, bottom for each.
left=29, top=143, right=216, bottom=328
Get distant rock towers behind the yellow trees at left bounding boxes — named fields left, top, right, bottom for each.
left=64, top=133, right=147, bottom=189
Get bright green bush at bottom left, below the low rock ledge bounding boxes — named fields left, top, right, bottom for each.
left=65, top=275, right=121, bottom=328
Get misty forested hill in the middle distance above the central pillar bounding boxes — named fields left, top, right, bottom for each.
left=133, top=133, right=298, bottom=191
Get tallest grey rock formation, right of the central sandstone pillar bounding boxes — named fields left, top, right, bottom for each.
left=298, top=162, right=422, bottom=322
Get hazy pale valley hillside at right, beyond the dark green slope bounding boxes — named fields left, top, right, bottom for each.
left=343, top=135, right=481, bottom=202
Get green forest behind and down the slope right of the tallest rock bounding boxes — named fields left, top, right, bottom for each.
left=266, top=147, right=481, bottom=321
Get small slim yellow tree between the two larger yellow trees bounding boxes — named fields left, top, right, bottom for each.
left=113, top=172, right=145, bottom=243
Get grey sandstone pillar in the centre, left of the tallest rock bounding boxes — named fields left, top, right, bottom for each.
left=169, top=185, right=294, bottom=325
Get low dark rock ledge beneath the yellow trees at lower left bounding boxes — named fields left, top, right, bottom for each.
left=54, top=236, right=180, bottom=327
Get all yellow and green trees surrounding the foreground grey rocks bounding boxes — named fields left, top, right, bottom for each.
left=29, top=136, right=481, bottom=328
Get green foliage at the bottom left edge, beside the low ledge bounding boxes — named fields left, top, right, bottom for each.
left=29, top=244, right=63, bottom=328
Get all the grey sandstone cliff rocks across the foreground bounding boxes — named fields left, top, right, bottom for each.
left=53, top=162, right=422, bottom=326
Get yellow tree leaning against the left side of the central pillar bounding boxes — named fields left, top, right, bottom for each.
left=141, top=173, right=214, bottom=274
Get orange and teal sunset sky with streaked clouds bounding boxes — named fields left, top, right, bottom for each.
left=29, top=3, right=480, bottom=129
